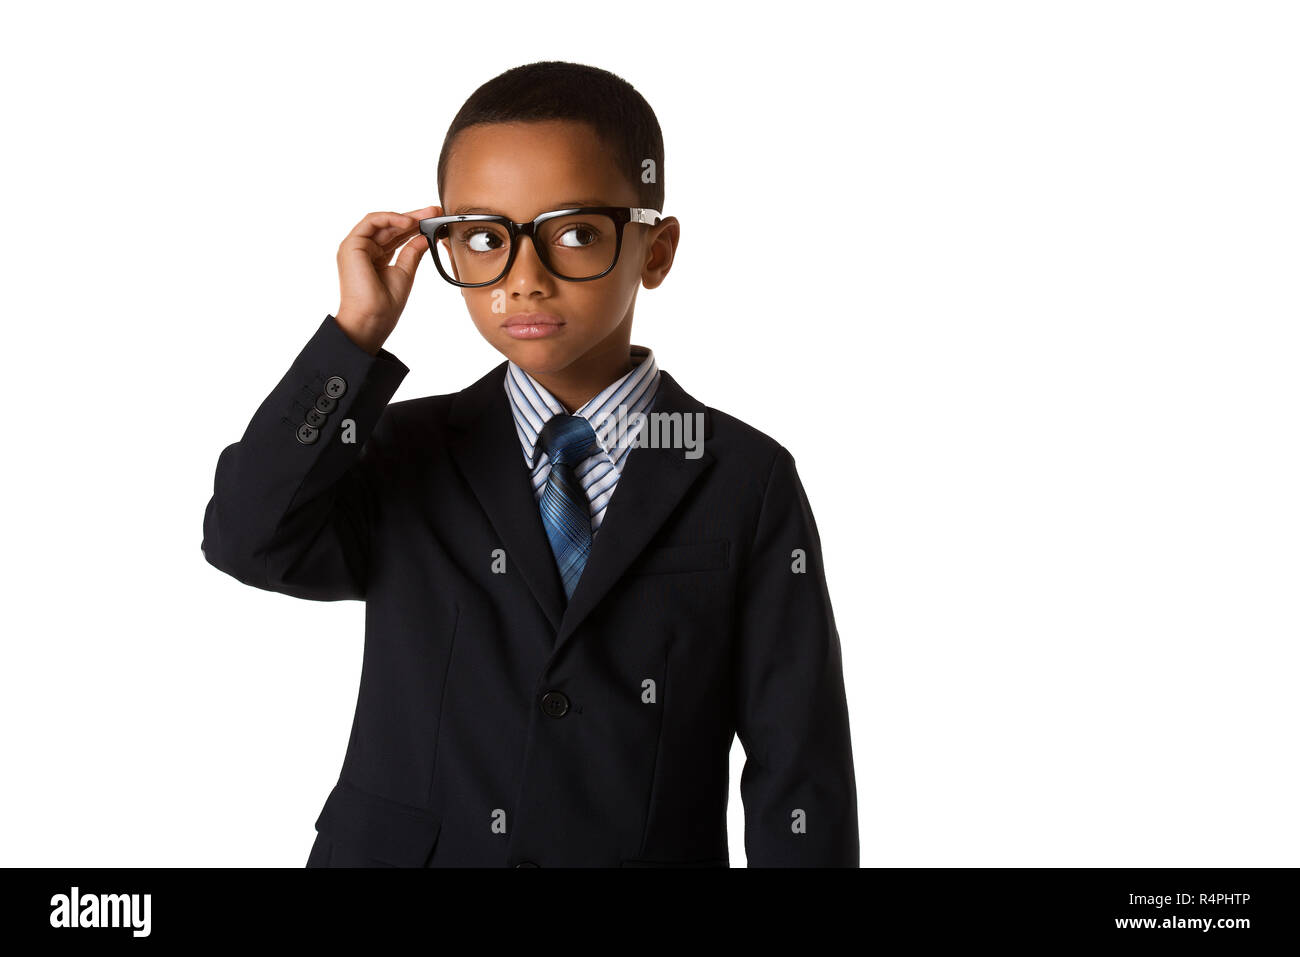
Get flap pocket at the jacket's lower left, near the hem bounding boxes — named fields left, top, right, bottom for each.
left=316, top=780, right=442, bottom=867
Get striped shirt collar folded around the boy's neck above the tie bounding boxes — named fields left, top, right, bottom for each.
left=506, top=346, right=659, bottom=471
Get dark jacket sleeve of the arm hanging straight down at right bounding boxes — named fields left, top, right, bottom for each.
left=733, top=447, right=859, bottom=867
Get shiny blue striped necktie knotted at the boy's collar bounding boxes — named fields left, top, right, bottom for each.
left=537, top=413, right=601, bottom=598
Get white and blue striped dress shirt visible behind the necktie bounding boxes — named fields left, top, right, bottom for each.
left=506, top=346, right=659, bottom=540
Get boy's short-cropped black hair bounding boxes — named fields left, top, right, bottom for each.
left=438, top=60, right=663, bottom=212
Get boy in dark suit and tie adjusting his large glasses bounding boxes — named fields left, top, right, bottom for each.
left=203, top=62, right=858, bottom=867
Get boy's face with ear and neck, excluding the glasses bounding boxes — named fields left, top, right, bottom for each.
left=442, top=120, right=677, bottom=381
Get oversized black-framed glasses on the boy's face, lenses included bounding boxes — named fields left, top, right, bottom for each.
left=420, top=205, right=663, bottom=287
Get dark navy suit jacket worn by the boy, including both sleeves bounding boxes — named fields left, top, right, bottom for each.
left=203, top=316, right=858, bottom=867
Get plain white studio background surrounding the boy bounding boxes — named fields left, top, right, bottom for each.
left=0, top=0, right=1300, bottom=867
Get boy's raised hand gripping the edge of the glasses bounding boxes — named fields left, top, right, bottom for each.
left=334, top=205, right=442, bottom=355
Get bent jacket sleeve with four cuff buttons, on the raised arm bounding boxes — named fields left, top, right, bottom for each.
left=200, top=316, right=410, bottom=601
